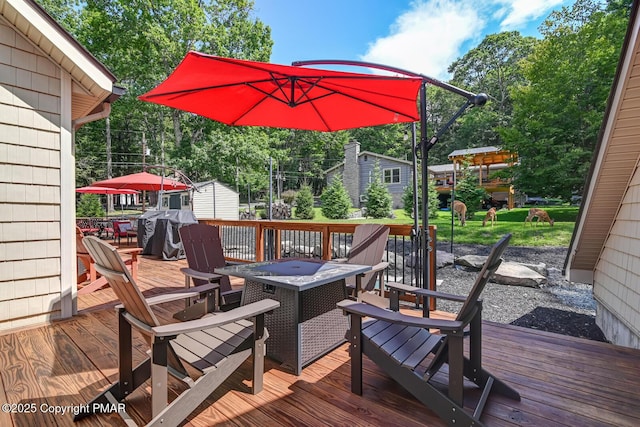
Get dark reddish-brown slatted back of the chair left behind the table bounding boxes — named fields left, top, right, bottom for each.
left=178, top=223, right=231, bottom=292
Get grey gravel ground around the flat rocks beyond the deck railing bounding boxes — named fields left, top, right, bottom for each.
left=436, top=242, right=606, bottom=341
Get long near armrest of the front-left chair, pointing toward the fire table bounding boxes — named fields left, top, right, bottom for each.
left=151, top=299, right=280, bottom=337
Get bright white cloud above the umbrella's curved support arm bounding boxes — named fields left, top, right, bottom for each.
left=362, top=0, right=485, bottom=80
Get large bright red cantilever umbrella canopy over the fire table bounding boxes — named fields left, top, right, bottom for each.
left=139, top=52, right=423, bottom=131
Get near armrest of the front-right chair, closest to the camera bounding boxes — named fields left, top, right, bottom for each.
left=337, top=300, right=465, bottom=333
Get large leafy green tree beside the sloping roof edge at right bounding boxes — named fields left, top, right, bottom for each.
left=500, top=0, right=628, bottom=200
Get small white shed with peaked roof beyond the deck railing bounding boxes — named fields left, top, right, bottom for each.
left=191, top=181, right=240, bottom=220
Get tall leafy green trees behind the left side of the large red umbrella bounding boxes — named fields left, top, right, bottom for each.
left=43, top=0, right=273, bottom=189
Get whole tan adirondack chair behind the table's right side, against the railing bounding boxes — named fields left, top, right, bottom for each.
left=333, top=224, right=389, bottom=299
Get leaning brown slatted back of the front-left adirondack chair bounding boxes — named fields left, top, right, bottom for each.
left=82, top=236, right=160, bottom=326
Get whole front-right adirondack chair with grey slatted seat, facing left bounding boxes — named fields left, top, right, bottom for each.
left=338, top=234, right=520, bottom=426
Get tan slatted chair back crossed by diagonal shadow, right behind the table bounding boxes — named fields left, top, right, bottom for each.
left=347, top=224, right=389, bottom=291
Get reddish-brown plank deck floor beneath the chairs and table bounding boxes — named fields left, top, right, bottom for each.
left=0, top=252, right=640, bottom=427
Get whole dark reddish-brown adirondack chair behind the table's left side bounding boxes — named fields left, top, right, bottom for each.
left=178, top=223, right=242, bottom=311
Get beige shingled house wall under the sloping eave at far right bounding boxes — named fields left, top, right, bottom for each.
left=593, top=159, right=640, bottom=348
